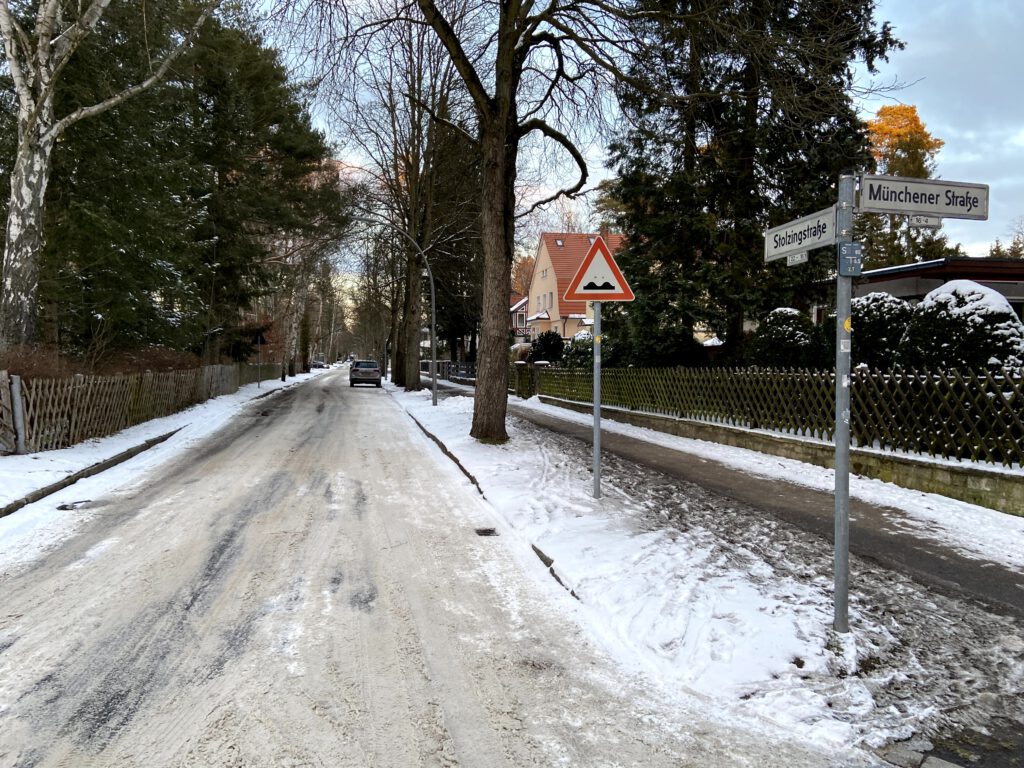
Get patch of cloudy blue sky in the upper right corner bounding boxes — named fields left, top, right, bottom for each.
left=864, top=0, right=1024, bottom=256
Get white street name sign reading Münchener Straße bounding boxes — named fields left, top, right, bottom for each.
left=857, top=174, right=988, bottom=221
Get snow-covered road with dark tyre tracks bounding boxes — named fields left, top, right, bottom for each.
left=0, top=375, right=872, bottom=768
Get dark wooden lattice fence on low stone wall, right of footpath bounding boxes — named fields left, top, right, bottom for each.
left=536, top=368, right=1024, bottom=467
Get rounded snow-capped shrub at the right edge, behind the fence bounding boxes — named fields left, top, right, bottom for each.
left=898, top=280, right=1024, bottom=371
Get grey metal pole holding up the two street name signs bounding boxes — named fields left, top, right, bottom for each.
left=833, top=174, right=859, bottom=633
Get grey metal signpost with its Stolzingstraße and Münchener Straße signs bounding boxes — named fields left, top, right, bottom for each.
left=765, top=173, right=988, bottom=633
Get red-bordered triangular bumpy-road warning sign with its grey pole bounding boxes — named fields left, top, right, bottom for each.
left=562, top=236, right=634, bottom=499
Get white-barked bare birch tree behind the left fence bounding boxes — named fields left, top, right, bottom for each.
left=0, top=0, right=220, bottom=351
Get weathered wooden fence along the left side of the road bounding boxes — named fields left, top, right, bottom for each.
left=0, top=366, right=279, bottom=453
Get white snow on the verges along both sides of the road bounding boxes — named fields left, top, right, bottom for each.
left=0, top=372, right=1024, bottom=746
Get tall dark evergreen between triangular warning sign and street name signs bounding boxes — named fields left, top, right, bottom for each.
left=608, top=0, right=898, bottom=365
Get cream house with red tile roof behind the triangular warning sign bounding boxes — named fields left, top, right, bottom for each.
left=526, top=232, right=625, bottom=339
